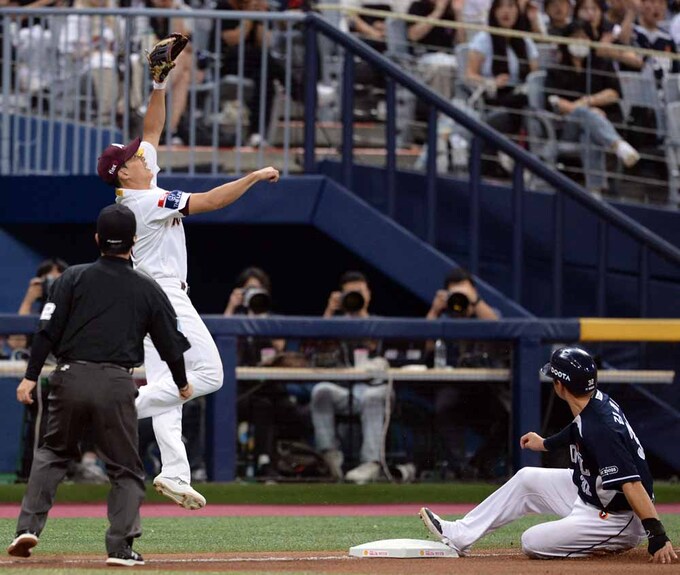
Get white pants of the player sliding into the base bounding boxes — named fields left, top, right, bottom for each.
left=442, top=467, right=645, bottom=559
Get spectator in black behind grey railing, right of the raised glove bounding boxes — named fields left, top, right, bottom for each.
left=215, top=0, right=294, bottom=147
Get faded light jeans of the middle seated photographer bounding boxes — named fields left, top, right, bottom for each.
left=310, top=381, right=387, bottom=463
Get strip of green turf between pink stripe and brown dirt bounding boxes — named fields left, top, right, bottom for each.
left=0, top=508, right=680, bottom=555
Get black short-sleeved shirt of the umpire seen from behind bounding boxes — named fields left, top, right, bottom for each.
left=26, top=256, right=191, bottom=381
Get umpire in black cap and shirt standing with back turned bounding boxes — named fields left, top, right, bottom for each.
left=7, top=204, right=193, bottom=567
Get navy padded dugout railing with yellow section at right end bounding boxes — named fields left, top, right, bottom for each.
left=0, top=314, right=680, bottom=481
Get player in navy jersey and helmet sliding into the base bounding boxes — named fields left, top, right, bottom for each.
left=420, top=347, right=678, bottom=563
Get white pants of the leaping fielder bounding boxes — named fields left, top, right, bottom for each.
left=136, top=279, right=224, bottom=483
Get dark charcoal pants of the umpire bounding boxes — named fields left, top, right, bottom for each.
left=17, top=363, right=144, bottom=553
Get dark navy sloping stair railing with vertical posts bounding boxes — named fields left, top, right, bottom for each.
left=304, top=14, right=680, bottom=317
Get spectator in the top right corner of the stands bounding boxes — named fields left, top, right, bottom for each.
left=633, top=0, right=680, bottom=84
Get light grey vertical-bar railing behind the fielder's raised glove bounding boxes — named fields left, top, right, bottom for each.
left=0, top=8, right=304, bottom=175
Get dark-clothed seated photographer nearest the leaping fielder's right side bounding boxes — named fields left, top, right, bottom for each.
left=224, top=267, right=311, bottom=477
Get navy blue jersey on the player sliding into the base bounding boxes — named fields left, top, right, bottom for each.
left=569, top=390, right=654, bottom=511
